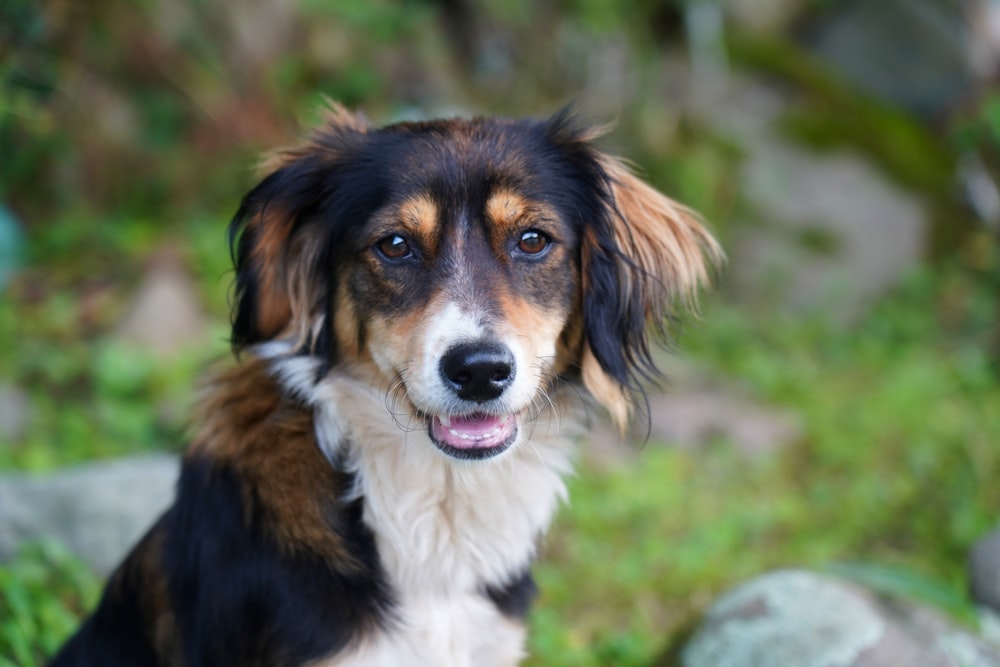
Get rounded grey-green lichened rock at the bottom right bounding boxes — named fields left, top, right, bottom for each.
left=679, top=570, right=1000, bottom=667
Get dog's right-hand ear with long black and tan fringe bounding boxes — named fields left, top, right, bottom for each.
left=581, top=156, right=723, bottom=430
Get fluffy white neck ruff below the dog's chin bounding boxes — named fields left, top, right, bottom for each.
left=262, top=350, right=580, bottom=598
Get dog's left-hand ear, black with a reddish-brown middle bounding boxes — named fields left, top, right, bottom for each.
left=229, top=104, right=367, bottom=350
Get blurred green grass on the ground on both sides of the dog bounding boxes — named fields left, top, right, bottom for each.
left=0, top=221, right=1000, bottom=667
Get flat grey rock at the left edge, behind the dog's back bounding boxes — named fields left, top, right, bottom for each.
left=0, top=454, right=179, bottom=574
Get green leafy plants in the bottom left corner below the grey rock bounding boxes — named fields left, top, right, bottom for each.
left=0, top=543, right=100, bottom=667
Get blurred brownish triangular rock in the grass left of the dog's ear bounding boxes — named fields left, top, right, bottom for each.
left=115, top=248, right=207, bottom=357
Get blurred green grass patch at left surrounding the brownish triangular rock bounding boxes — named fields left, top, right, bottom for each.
left=0, top=218, right=228, bottom=470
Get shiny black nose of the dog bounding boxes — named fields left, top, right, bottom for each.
left=441, top=343, right=514, bottom=403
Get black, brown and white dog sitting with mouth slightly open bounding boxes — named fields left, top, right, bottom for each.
left=51, top=105, right=721, bottom=667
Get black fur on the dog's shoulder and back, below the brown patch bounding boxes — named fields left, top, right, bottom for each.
left=51, top=459, right=392, bottom=667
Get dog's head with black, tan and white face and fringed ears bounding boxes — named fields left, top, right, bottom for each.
left=231, top=107, right=719, bottom=459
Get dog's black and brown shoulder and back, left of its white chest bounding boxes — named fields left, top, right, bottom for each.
left=53, top=360, right=391, bottom=667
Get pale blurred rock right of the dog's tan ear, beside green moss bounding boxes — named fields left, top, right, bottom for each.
left=703, top=75, right=930, bottom=322
